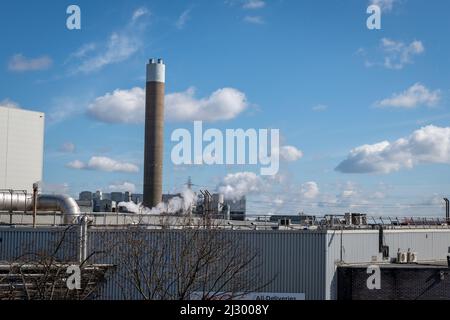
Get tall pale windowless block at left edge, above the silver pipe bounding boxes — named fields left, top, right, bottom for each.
left=0, top=107, right=45, bottom=193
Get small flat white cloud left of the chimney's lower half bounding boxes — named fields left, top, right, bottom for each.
left=67, top=157, right=139, bottom=173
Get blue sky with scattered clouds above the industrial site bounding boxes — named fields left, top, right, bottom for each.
left=0, top=0, right=450, bottom=215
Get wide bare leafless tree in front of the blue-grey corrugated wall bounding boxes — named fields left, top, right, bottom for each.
left=104, top=216, right=271, bottom=300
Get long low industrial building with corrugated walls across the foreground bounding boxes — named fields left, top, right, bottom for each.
left=0, top=214, right=450, bottom=300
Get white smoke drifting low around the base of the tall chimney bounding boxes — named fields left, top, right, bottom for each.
left=119, top=189, right=197, bottom=215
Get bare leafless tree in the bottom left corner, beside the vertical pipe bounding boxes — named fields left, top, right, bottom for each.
left=0, top=226, right=108, bottom=300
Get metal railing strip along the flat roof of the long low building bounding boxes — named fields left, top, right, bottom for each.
left=0, top=212, right=450, bottom=230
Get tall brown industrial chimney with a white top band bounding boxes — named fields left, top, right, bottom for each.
left=143, top=59, right=166, bottom=208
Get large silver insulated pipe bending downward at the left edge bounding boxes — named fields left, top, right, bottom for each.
left=0, top=192, right=81, bottom=224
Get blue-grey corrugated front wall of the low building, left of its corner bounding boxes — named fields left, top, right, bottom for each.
left=0, top=228, right=326, bottom=300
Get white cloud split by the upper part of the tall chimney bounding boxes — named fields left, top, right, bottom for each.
left=88, top=87, right=248, bottom=123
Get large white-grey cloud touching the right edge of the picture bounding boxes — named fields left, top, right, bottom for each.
left=336, top=125, right=450, bottom=174
